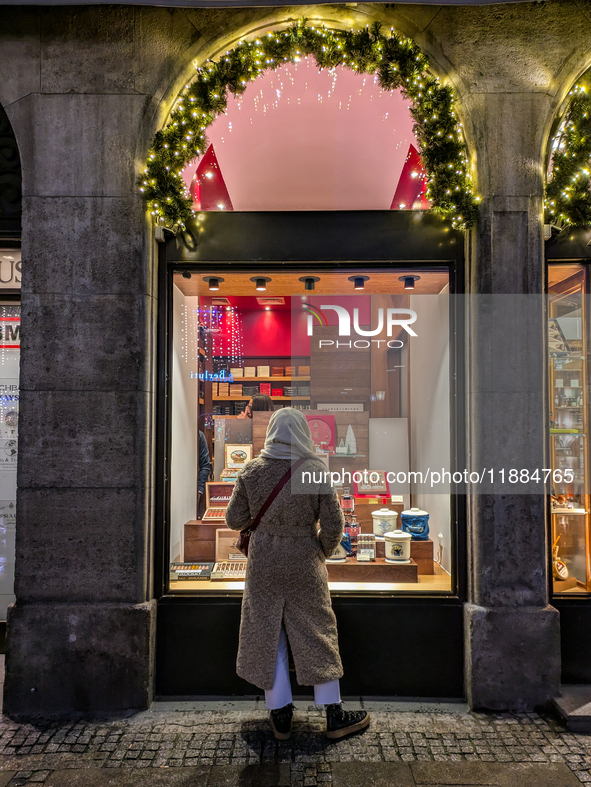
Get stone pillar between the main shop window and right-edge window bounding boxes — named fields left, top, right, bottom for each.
left=465, top=92, right=560, bottom=710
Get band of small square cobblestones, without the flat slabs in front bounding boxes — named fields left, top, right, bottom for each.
left=0, top=703, right=591, bottom=787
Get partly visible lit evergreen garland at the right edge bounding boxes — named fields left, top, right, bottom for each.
left=545, top=71, right=591, bottom=227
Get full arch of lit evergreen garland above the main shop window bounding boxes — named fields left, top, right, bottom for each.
left=138, top=20, right=479, bottom=229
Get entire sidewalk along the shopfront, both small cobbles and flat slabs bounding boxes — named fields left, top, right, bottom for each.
left=0, top=700, right=591, bottom=787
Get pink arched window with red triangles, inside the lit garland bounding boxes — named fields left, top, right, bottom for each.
left=178, top=58, right=429, bottom=211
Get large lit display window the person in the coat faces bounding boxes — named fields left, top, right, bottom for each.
left=169, top=267, right=455, bottom=593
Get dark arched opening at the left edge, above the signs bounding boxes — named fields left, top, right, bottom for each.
left=0, top=106, right=22, bottom=238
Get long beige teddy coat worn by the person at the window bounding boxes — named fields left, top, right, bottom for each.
left=226, top=457, right=344, bottom=689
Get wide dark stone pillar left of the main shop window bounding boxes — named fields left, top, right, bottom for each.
left=4, top=7, right=155, bottom=718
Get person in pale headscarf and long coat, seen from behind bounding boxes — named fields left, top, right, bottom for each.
left=226, top=407, right=369, bottom=740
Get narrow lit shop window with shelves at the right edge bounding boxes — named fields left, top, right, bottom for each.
left=548, top=263, right=591, bottom=594
